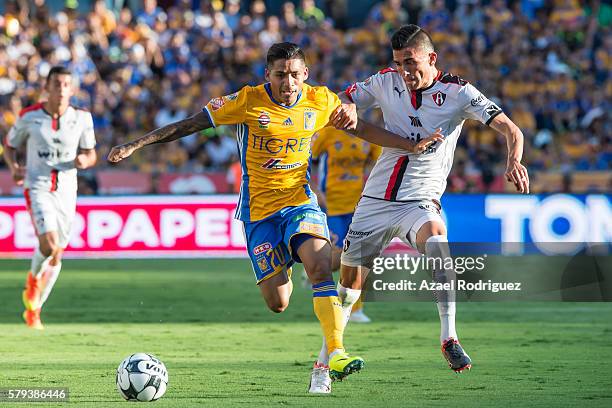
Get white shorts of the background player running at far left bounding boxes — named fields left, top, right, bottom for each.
left=24, top=189, right=77, bottom=248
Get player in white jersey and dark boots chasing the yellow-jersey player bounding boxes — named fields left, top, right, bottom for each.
left=308, top=25, right=529, bottom=392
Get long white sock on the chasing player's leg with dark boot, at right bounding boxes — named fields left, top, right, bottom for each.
left=425, top=235, right=457, bottom=343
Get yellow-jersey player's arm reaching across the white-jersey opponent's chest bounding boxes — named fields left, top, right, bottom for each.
left=346, top=119, right=444, bottom=153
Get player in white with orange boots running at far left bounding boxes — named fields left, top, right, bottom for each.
left=4, top=66, right=96, bottom=329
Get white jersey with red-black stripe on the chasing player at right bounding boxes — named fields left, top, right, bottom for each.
left=345, top=68, right=502, bottom=201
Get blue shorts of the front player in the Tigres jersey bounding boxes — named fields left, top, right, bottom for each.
left=244, top=204, right=330, bottom=284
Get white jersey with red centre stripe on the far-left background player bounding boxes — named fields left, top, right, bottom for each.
left=6, top=103, right=96, bottom=191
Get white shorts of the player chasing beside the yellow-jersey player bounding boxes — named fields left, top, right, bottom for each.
left=342, top=197, right=444, bottom=268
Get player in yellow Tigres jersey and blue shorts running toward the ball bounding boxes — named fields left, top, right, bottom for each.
left=108, top=43, right=441, bottom=392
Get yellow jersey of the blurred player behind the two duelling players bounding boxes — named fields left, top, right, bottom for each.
left=312, top=127, right=382, bottom=215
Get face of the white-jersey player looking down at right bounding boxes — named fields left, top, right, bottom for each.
left=393, top=47, right=438, bottom=90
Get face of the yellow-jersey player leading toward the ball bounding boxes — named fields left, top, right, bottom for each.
left=266, top=58, right=308, bottom=105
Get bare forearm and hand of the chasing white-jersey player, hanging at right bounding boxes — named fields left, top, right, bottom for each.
left=489, top=113, right=529, bottom=194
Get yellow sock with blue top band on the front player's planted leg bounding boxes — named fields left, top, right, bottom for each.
left=312, top=281, right=344, bottom=353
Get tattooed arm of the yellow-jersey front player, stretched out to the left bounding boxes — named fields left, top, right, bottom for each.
left=108, top=111, right=213, bottom=163
